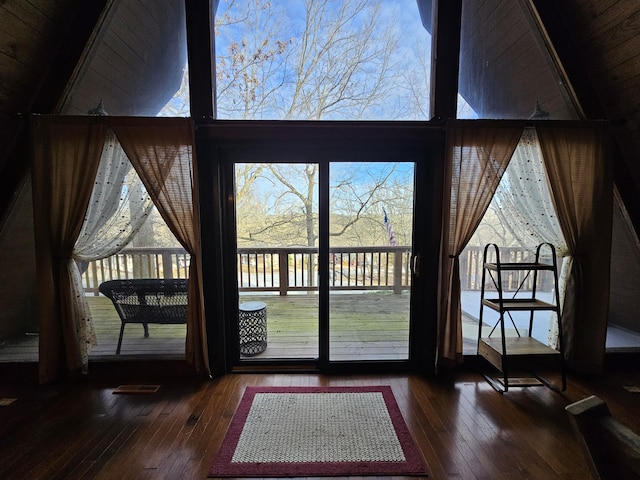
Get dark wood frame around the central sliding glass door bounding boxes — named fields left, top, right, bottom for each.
left=197, top=121, right=444, bottom=375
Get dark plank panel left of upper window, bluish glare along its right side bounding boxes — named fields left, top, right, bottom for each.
left=62, top=0, right=187, bottom=116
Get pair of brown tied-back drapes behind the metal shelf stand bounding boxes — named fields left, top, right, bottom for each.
left=436, top=121, right=613, bottom=372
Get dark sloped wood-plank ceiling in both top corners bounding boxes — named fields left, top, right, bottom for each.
left=0, top=0, right=640, bottom=234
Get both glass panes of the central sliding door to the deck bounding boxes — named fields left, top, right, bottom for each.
left=234, top=158, right=414, bottom=362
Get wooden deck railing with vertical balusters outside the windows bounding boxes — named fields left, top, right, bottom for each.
left=82, top=246, right=546, bottom=295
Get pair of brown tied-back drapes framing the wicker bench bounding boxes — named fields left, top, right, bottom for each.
left=32, top=116, right=209, bottom=382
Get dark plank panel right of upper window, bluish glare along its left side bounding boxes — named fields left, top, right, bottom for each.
left=460, top=0, right=577, bottom=119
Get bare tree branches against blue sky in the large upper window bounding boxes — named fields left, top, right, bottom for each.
left=216, top=0, right=401, bottom=120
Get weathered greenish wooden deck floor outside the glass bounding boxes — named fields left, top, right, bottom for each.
left=0, top=292, right=477, bottom=362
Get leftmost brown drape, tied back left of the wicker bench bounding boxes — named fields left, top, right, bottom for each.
left=32, top=116, right=107, bottom=382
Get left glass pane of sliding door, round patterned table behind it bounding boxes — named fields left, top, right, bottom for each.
left=235, top=163, right=319, bottom=360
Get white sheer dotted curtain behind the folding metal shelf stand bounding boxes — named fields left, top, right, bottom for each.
left=494, top=128, right=571, bottom=348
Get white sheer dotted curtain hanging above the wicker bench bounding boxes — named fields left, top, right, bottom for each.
left=71, top=130, right=153, bottom=371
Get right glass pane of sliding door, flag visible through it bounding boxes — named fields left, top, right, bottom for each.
left=328, top=162, right=414, bottom=361
